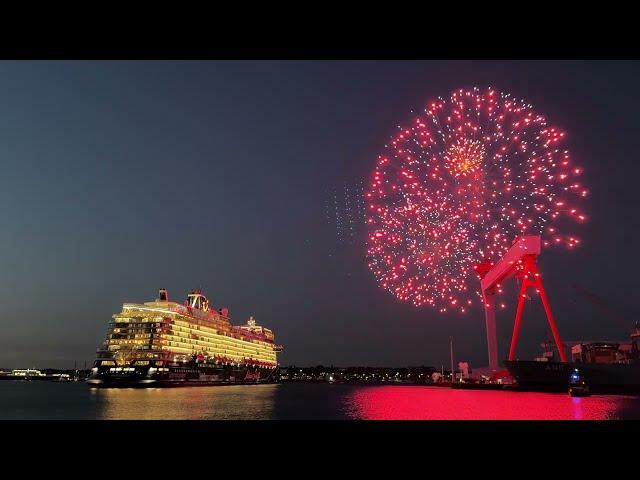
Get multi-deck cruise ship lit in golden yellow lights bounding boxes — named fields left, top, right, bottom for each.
left=88, top=289, right=282, bottom=387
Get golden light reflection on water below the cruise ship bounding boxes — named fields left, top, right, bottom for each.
left=92, top=385, right=279, bottom=420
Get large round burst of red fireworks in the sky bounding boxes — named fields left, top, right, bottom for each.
left=365, top=88, right=587, bottom=313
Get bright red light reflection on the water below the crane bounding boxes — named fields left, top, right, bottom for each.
left=345, top=386, right=627, bottom=420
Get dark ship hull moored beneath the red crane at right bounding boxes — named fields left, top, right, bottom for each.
left=503, top=360, right=640, bottom=393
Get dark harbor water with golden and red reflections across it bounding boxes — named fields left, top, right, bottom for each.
left=0, top=381, right=640, bottom=420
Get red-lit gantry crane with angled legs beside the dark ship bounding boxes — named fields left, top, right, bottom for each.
left=473, top=235, right=567, bottom=371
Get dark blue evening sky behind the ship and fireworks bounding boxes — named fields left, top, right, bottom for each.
left=0, top=61, right=640, bottom=367
